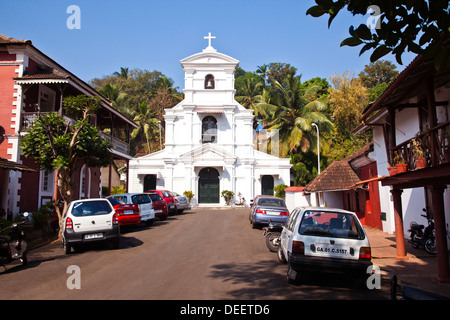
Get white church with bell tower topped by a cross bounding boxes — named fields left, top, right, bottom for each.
left=128, top=33, right=291, bottom=206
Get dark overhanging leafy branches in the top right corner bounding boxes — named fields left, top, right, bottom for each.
left=306, top=0, right=450, bottom=70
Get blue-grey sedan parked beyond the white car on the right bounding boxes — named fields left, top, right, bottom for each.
left=249, top=196, right=289, bottom=228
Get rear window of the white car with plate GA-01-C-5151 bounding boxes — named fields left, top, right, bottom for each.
left=299, top=211, right=364, bottom=240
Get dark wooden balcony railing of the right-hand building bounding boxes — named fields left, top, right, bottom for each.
left=393, top=121, right=450, bottom=170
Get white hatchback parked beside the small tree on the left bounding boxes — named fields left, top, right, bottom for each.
left=62, top=199, right=120, bottom=254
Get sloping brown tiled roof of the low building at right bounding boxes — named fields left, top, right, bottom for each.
left=304, top=160, right=361, bottom=192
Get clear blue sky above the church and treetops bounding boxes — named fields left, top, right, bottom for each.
left=0, top=0, right=414, bottom=89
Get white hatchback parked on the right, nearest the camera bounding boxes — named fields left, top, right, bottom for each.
left=278, top=207, right=372, bottom=283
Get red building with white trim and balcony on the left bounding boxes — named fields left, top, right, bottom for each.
left=0, top=34, right=136, bottom=217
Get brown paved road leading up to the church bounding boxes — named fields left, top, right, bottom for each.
left=0, top=208, right=389, bottom=300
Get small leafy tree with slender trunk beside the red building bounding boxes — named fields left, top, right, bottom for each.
left=20, top=95, right=112, bottom=230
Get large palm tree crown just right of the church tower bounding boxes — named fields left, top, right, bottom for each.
left=256, top=75, right=333, bottom=157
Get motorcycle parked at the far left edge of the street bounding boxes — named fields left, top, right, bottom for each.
left=0, top=212, right=28, bottom=269
